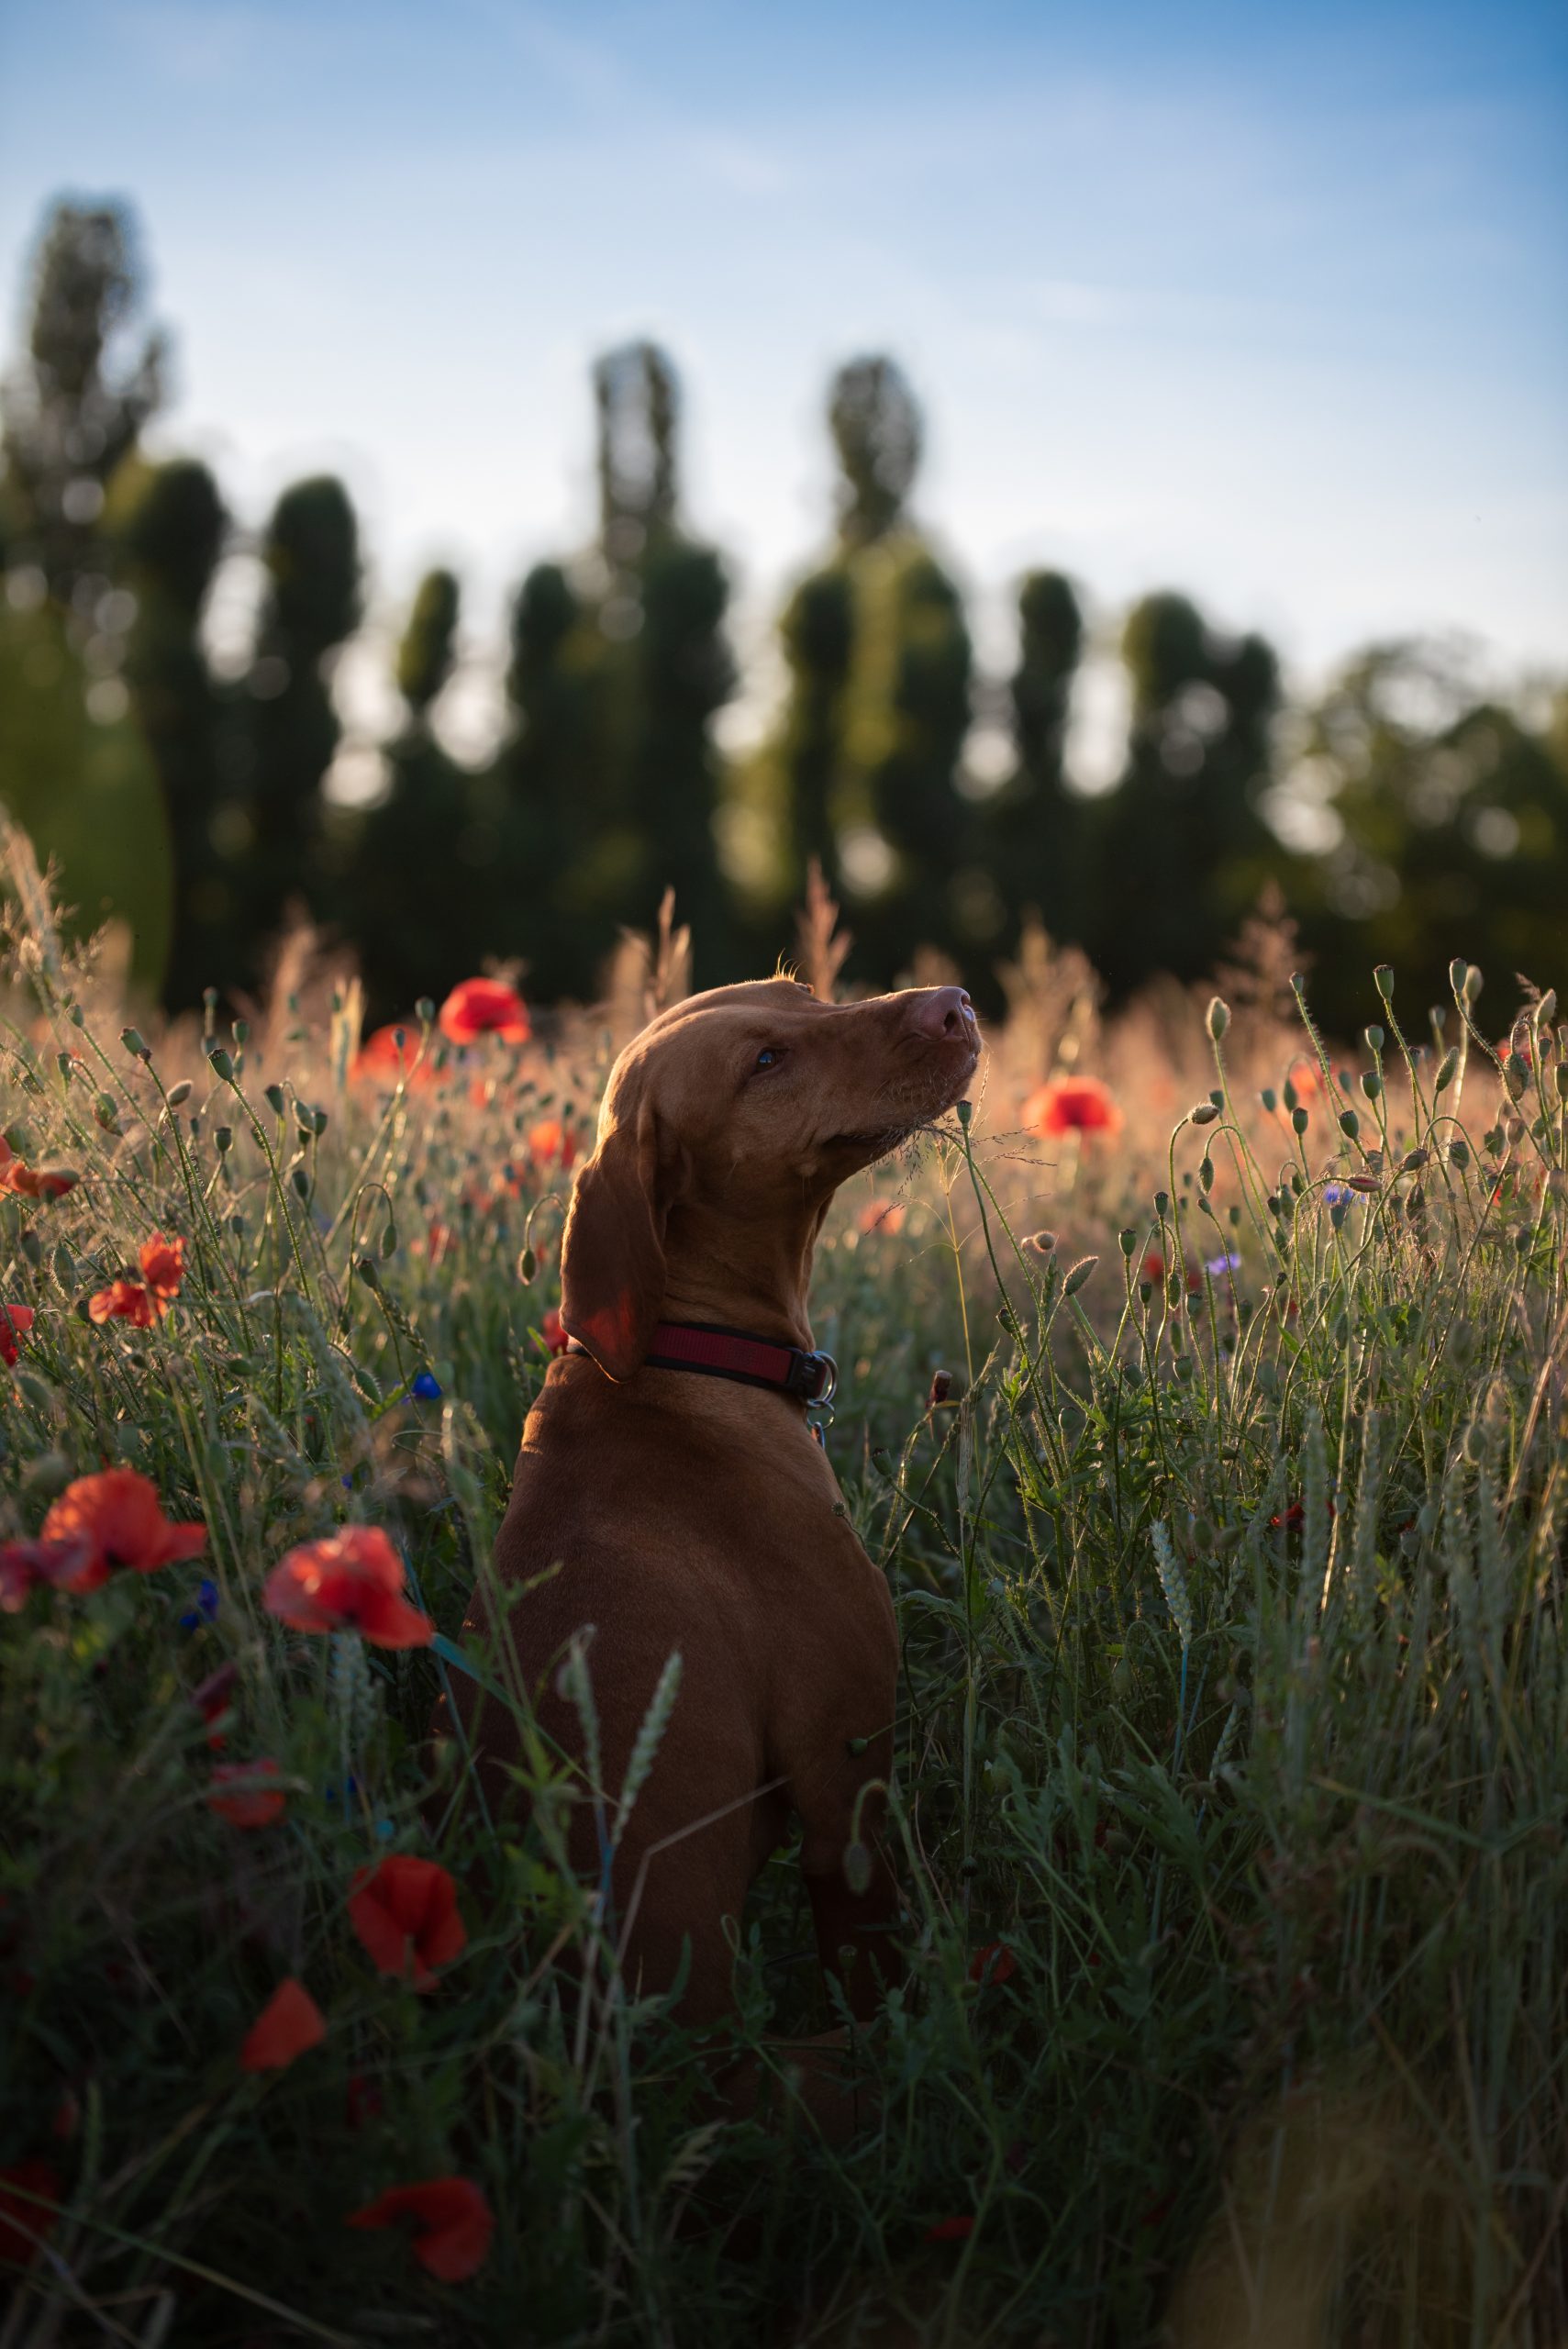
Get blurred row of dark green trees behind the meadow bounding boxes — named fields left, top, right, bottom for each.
left=0, top=202, right=1568, bottom=1042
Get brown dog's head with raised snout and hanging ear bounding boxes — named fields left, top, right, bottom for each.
left=561, top=980, right=979, bottom=1379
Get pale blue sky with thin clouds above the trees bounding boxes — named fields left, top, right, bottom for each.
left=0, top=0, right=1568, bottom=761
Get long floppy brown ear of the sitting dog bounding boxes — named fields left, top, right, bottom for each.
left=561, top=1104, right=669, bottom=1379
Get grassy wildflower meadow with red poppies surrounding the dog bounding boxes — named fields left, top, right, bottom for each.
left=0, top=843, right=1568, bottom=2349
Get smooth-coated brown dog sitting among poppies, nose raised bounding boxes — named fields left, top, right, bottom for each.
left=443, top=980, right=979, bottom=2057
